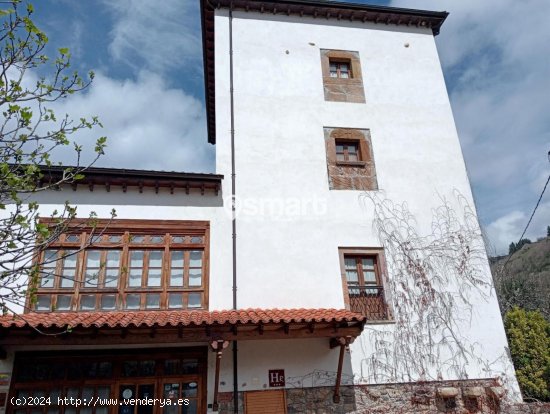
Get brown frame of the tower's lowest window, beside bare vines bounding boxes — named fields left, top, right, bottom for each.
left=338, top=247, right=394, bottom=323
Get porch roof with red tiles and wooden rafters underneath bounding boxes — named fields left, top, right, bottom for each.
left=0, top=309, right=366, bottom=345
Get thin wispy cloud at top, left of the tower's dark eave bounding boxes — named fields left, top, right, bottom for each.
left=103, top=0, right=202, bottom=73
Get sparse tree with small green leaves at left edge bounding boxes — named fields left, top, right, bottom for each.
left=0, top=0, right=110, bottom=313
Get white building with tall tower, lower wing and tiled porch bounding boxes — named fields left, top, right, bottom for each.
left=0, top=0, right=519, bottom=414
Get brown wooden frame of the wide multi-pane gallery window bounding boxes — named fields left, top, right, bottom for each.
left=26, top=219, right=210, bottom=312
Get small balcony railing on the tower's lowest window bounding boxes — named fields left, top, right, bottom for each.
left=348, top=285, right=391, bottom=321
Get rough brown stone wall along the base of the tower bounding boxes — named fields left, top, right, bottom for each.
left=219, top=379, right=550, bottom=414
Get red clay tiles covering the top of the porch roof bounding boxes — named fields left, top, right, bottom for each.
left=0, top=309, right=366, bottom=328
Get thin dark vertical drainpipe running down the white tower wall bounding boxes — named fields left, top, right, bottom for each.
left=229, top=3, right=239, bottom=414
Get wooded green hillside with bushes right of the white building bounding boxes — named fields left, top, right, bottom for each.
left=491, top=234, right=550, bottom=401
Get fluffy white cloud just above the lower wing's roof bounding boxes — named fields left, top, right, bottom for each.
left=48, top=72, right=214, bottom=172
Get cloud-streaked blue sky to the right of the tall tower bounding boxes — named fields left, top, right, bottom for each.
left=392, top=0, right=550, bottom=253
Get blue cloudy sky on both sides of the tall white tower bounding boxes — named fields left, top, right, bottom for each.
left=22, top=0, right=550, bottom=254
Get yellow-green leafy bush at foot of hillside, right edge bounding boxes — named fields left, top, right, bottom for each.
left=504, top=307, right=550, bottom=401
